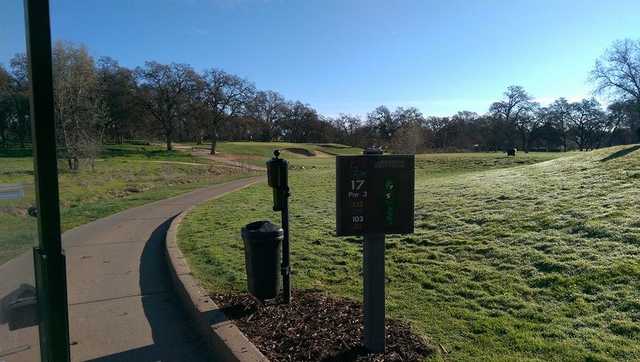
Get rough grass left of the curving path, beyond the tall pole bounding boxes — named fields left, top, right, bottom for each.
left=0, top=145, right=260, bottom=264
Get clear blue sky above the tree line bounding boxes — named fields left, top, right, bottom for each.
left=0, top=0, right=640, bottom=116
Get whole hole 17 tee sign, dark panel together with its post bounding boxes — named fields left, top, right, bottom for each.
left=336, top=150, right=415, bottom=353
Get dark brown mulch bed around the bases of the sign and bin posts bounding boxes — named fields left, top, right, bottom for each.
left=212, top=290, right=436, bottom=362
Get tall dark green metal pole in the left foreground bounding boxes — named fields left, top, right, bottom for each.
left=24, top=0, right=70, bottom=362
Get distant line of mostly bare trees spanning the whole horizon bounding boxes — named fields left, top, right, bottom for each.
left=0, top=40, right=640, bottom=169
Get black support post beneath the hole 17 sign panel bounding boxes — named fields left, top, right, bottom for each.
left=363, top=234, right=385, bottom=353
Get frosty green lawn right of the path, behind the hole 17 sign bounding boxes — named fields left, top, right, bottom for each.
left=179, top=146, right=640, bottom=361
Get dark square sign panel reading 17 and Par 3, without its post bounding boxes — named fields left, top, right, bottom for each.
left=336, top=155, right=415, bottom=236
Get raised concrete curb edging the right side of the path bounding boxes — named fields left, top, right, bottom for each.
left=165, top=207, right=269, bottom=362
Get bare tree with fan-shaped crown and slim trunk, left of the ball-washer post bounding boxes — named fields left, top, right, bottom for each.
left=203, top=69, right=255, bottom=155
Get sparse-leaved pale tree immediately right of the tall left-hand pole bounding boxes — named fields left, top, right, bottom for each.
left=52, top=42, right=108, bottom=170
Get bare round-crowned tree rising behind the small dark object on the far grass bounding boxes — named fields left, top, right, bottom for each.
left=489, top=86, right=536, bottom=151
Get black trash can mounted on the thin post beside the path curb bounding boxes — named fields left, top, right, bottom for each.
left=242, top=221, right=284, bottom=300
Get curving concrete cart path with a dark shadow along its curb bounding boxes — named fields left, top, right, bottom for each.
left=0, top=178, right=260, bottom=362
